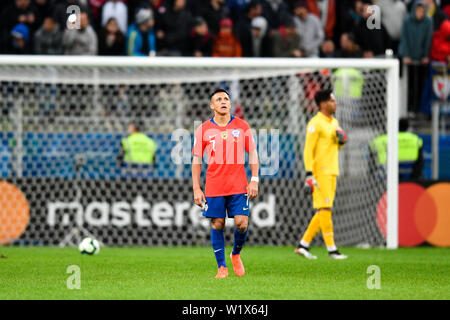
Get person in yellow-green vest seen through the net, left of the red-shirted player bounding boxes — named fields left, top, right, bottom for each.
left=117, top=121, right=158, bottom=167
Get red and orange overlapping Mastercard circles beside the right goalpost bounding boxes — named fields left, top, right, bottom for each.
left=377, top=182, right=450, bottom=247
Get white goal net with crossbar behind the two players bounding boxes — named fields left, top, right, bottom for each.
left=0, top=56, right=398, bottom=247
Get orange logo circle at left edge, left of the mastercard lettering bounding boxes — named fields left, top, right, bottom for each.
left=0, top=181, right=30, bottom=245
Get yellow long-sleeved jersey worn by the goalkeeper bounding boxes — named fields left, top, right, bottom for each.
left=303, top=111, right=341, bottom=176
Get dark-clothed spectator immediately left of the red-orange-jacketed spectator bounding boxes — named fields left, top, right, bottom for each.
left=189, top=17, right=213, bottom=57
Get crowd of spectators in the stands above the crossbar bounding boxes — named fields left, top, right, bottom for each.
left=0, top=0, right=450, bottom=60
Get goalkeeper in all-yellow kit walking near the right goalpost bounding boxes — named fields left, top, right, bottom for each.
left=295, top=90, right=347, bottom=259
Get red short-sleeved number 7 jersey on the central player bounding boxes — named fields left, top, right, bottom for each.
left=192, top=116, right=256, bottom=197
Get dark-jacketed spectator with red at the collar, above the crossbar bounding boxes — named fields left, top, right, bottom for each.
left=271, top=16, right=302, bottom=58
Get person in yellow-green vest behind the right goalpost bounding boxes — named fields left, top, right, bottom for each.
left=370, top=118, right=424, bottom=181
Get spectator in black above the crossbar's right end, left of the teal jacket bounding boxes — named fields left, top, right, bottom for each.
left=354, top=3, right=391, bottom=58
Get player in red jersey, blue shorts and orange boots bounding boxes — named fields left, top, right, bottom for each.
left=192, top=89, right=259, bottom=278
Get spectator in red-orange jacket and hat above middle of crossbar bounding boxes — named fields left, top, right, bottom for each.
left=212, top=18, right=242, bottom=57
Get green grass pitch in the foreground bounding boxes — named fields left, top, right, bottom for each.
left=0, top=247, right=450, bottom=300
